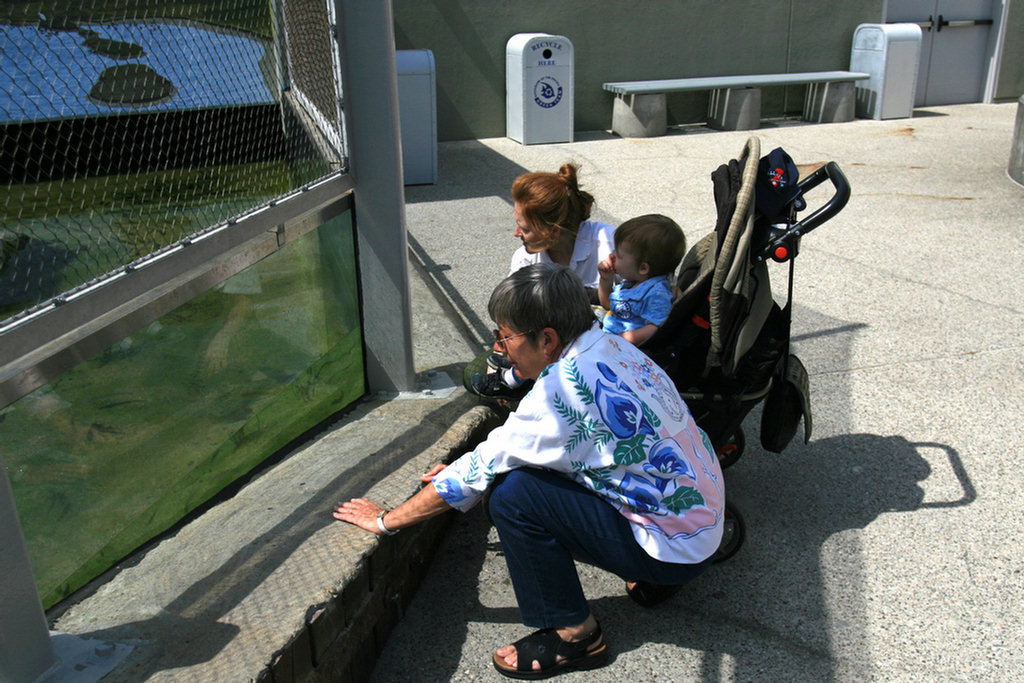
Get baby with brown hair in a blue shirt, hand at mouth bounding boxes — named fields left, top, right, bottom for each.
left=597, top=214, right=686, bottom=345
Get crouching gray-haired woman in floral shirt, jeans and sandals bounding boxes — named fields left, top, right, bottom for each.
left=334, top=263, right=725, bottom=679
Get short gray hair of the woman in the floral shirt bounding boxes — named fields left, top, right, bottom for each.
left=487, top=263, right=595, bottom=346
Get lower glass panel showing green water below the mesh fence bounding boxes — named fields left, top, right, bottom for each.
left=0, top=212, right=366, bottom=606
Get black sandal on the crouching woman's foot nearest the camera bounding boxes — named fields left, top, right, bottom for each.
left=492, top=624, right=608, bottom=680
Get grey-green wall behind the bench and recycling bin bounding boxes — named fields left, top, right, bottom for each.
left=392, top=0, right=883, bottom=140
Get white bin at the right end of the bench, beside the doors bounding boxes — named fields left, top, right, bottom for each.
left=850, top=24, right=921, bottom=119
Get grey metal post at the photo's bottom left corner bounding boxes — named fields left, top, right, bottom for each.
left=0, top=452, right=55, bottom=683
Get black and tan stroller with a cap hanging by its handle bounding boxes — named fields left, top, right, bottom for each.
left=642, top=137, right=850, bottom=561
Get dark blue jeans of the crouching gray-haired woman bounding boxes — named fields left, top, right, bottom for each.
left=488, top=467, right=712, bottom=629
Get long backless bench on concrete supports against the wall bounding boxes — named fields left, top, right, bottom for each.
left=603, top=71, right=870, bottom=137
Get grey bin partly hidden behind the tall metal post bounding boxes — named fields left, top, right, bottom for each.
left=394, top=50, right=437, bottom=185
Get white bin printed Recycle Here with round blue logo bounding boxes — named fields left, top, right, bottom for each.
left=505, top=33, right=574, bottom=144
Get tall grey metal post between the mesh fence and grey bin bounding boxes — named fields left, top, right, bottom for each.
left=334, top=0, right=416, bottom=391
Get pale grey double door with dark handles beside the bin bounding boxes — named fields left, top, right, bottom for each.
left=886, top=0, right=998, bottom=106
